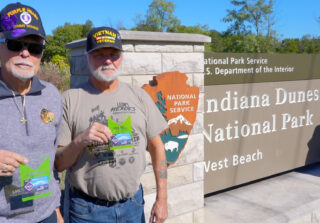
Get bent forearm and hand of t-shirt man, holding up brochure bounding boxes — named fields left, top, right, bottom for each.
left=54, top=122, right=111, bottom=172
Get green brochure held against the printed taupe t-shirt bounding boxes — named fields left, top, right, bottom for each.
left=108, top=115, right=132, bottom=150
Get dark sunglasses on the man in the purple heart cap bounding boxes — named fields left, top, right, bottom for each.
left=0, top=39, right=45, bottom=55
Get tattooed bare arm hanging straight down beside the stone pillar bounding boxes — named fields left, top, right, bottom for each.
left=148, top=136, right=168, bottom=223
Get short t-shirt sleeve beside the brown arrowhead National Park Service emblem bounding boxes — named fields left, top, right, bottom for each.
left=142, top=90, right=168, bottom=140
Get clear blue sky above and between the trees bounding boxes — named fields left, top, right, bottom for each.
left=0, top=0, right=320, bottom=39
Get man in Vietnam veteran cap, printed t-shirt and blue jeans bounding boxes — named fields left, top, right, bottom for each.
left=55, top=27, right=168, bottom=223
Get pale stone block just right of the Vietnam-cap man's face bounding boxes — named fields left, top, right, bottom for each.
left=121, top=52, right=162, bottom=74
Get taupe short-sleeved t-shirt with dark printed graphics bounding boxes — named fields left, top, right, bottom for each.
left=59, top=82, right=168, bottom=201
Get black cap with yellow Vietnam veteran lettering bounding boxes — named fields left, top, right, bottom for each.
left=87, top=27, right=122, bottom=53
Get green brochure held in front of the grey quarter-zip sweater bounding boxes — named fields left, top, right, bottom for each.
left=20, top=157, right=51, bottom=202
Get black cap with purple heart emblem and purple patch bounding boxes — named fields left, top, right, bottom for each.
left=0, top=2, right=46, bottom=40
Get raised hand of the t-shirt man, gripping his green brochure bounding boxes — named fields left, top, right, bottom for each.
left=75, top=122, right=112, bottom=147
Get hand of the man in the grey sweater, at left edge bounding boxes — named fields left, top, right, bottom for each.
left=0, top=150, right=28, bottom=177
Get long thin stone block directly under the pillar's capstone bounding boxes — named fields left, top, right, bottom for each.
left=135, top=42, right=193, bottom=53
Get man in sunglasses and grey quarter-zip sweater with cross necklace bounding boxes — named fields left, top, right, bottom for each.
left=0, top=3, right=62, bottom=223
